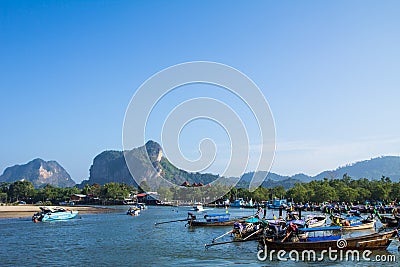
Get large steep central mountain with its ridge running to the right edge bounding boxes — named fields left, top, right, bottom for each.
left=83, top=141, right=400, bottom=188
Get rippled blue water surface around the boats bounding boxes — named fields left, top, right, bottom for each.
left=0, top=206, right=400, bottom=266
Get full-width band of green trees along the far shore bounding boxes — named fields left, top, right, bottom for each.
left=0, top=174, right=400, bottom=204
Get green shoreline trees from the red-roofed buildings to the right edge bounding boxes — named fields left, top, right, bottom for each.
left=149, top=174, right=400, bottom=203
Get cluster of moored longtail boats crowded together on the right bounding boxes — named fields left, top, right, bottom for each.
left=152, top=202, right=400, bottom=258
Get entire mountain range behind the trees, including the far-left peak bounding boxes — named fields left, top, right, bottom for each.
left=0, top=144, right=400, bottom=189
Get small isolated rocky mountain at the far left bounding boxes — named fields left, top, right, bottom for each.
left=0, top=158, right=75, bottom=188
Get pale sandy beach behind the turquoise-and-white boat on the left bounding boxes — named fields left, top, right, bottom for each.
left=0, top=205, right=113, bottom=219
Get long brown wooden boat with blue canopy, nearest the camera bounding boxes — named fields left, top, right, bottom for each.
left=259, top=226, right=397, bottom=251
